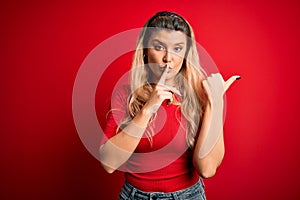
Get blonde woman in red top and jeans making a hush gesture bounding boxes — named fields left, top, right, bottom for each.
left=99, top=12, right=239, bottom=200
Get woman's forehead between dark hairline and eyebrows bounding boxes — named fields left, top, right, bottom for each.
left=149, top=29, right=187, bottom=45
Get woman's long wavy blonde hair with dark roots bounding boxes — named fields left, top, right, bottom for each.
left=121, top=11, right=207, bottom=148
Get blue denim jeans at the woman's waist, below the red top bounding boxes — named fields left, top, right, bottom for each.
left=119, top=178, right=206, bottom=200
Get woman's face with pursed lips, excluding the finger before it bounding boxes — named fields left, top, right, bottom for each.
left=146, top=30, right=187, bottom=85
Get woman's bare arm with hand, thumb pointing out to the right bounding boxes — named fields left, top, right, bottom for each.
left=193, top=74, right=239, bottom=178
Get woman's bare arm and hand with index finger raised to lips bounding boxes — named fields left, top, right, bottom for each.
left=99, top=66, right=173, bottom=173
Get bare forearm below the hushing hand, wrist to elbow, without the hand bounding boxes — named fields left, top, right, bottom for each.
left=99, top=108, right=151, bottom=173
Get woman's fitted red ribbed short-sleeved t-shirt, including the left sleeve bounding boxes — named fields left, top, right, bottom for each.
left=102, top=87, right=199, bottom=192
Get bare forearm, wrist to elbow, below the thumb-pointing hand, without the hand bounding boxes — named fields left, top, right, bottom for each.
left=193, top=101, right=225, bottom=178
